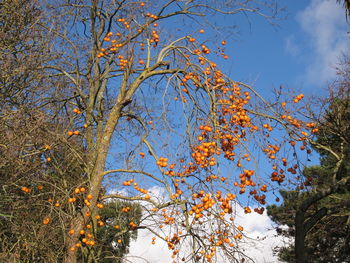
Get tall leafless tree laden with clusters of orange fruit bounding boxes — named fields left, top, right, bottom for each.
left=2, top=0, right=326, bottom=263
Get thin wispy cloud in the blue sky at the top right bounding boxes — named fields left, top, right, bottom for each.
left=286, top=0, right=350, bottom=85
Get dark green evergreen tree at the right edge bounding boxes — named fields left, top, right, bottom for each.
left=267, top=64, right=350, bottom=262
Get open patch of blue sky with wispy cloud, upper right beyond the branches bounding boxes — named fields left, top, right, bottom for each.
left=223, top=0, right=350, bottom=95
